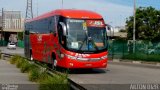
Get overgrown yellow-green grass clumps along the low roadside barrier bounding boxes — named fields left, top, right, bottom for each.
left=10, top=55, right=69, bottom=90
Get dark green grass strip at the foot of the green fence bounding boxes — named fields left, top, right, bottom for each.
left=122, top=53, right=160, bottom=62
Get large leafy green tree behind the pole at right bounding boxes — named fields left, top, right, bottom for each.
left=126, top=7, right=160, bottom=41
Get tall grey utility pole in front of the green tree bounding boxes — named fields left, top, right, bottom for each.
left=133, top=0, right=136, bottom=53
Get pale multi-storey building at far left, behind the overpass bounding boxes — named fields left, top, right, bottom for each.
left=0, top=11, right=24, bottom=42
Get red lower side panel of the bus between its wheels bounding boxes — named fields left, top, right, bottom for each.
left=30, top=34, right=54, bottom=63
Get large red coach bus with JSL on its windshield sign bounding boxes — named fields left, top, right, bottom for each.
left=24, top=9, right=108, bottom=68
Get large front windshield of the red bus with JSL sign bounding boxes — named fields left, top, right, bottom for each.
left=66, top=19, right=107, bottom=52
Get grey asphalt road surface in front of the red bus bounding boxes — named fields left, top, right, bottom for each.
left=69, top=63, right=160, bottom=90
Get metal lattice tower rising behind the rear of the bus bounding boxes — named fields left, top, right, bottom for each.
left=25, top=0, right=33, bottom=21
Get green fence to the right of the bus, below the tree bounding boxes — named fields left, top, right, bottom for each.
left=108, top=40, right=160, bottom=61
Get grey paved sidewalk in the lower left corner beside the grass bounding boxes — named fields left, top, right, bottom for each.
left=0, top=60, right=38, bottom=90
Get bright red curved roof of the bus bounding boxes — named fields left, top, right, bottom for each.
left=27, top=9, right=102, bottom=22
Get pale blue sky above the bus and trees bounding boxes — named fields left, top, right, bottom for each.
left=0, top=0, right=160, bottom=26
